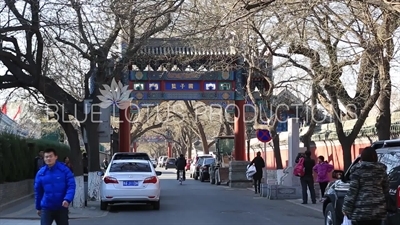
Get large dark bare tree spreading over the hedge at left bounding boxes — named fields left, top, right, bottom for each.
left=0, top=0, right=183, bottom=171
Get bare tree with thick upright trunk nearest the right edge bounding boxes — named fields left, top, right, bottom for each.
left=348, top=1, right=400, bottom=140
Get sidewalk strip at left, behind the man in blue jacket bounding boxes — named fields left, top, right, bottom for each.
left=0, top=198, right=108, bottom=220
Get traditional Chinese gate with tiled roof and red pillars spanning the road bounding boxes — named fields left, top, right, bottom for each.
left=119, top=39, right=246, bottom=161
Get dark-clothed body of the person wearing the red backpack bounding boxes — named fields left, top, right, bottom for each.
left=295, top=150, right=317, bottom=204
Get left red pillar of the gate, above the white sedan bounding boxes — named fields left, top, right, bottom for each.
left=119, top=108, right=131, bottom=152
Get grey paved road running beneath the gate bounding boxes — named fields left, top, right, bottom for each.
left=0, top=170, right=323, bottom=225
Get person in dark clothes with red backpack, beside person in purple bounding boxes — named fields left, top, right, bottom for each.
left=293, top=150, right=317, bottom=204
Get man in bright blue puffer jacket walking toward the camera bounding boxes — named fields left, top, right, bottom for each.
left=35, top=148, right=76, bottom=225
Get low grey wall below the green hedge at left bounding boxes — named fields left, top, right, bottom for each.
left=0, top=180, right=33, bottom=205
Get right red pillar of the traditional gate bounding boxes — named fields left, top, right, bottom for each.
left=234, top=100, right=246, bottom=161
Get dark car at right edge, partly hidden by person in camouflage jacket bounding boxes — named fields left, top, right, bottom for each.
left=323, top=140, right=400, bottom=225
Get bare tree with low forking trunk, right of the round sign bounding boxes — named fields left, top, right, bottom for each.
left=245, top=2, right=390, bottom=167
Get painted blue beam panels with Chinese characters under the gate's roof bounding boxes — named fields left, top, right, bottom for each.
left=128, top=71, right=241, bottom=111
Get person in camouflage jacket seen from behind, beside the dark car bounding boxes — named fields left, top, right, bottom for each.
left=342, top=147, right=389, bottom=225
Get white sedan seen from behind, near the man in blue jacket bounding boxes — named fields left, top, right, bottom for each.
left=98, top=159, right=161, bottom=210
